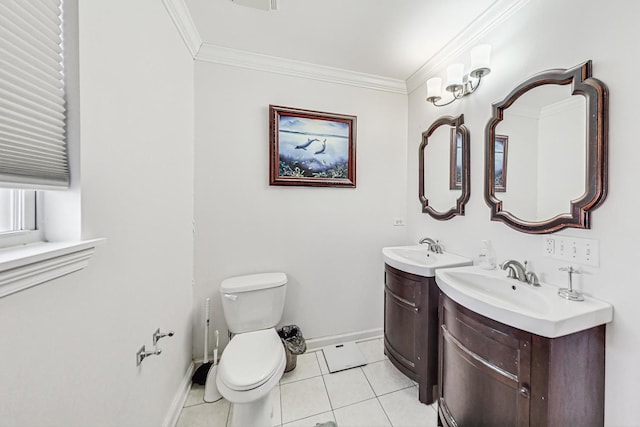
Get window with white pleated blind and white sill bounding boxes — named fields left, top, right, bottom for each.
left=0, top=0, right=97, bottom=298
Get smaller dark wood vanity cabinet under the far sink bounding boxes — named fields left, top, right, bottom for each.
left=384, top=264, right=438, bottom=404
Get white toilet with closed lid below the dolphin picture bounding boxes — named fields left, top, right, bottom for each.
left=216, top=273, right=287, bottom=427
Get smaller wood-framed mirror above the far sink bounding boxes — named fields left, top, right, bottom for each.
left=418, top=114, right=469, bottom=220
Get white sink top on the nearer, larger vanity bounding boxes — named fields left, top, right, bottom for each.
left=436, top=266, right=613, bottom=338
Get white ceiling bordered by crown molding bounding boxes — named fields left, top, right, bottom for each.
left=185, top=0, right=498, bottom=81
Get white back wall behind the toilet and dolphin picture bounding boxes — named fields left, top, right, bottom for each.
left=194, top=61, right=407, bottom=358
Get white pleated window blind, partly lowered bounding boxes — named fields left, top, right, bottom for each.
left=0, top=0, right=69, bottom=189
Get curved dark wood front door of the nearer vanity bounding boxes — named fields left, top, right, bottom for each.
left=438, top=294, right=531, bottom=427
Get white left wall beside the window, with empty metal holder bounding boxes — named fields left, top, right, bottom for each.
left=0, top=0, right=193, bottom=427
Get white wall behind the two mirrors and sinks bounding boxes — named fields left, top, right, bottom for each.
left=407, top=0, right=640, bottom=427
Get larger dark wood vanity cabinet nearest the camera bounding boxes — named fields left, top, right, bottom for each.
left=438, top=293, right=605, bottom=427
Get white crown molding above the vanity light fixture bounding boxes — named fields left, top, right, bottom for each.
left=406, top=0, right=530, bottom=93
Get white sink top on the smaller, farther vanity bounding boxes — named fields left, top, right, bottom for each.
left=382, top=245, right=473, bottom=277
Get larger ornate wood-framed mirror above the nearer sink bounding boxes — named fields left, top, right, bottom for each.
left=485, top=61, right=608, bottom=234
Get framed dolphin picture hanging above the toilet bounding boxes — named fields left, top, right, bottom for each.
left=269, top=105, right=356, bottom=187
